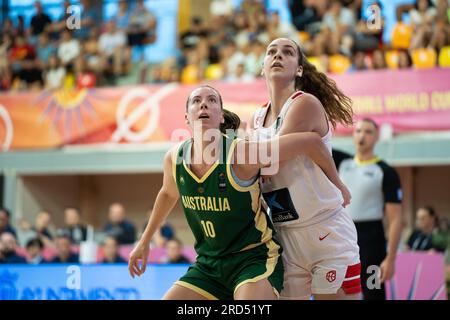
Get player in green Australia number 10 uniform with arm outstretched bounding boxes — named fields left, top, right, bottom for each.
left=129, top=86, right=346, bottom=299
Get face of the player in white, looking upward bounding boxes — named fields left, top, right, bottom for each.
left=263, top=38, right=303, bottom=81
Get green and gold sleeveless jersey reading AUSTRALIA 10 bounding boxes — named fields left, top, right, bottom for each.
left=172, top=136, right=278, bottom=257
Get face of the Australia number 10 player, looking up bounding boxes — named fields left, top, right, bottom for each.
left=185, top=87, right=224, bottom=129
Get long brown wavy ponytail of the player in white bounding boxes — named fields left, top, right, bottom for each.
left=291, top=40, right=353, bottom=127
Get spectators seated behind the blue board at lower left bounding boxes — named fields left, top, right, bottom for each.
left=0, top=203, right=193, bottom=264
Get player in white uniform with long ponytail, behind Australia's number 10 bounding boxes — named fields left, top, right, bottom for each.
left=252, top=38, right=361, bottom=299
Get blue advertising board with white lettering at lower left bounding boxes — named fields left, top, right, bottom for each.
left=0, top=264, right=188, bottom=300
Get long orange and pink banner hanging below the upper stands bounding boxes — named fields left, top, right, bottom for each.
left=0, top=69, right=450, bottom=151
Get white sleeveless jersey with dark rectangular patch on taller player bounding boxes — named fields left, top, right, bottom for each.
left=254, top=91, right=343, bottom=226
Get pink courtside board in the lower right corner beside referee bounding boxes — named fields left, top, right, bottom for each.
left=386, top=252, right=447, bottom=300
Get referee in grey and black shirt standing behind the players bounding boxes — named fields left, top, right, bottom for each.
left=333, top=118, right=402, bottom=300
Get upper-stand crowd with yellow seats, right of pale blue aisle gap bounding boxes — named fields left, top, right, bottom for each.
left=156, top=0, right=450, bottom=84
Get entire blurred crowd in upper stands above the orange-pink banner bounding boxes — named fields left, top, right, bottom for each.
left=0, top=0, right=450, bottom=90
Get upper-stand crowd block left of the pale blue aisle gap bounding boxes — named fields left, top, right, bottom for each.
left=0, top=0, right=156, bottom=91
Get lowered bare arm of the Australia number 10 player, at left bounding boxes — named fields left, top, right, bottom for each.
left=128, top=149, right=179, bottom=278
